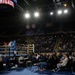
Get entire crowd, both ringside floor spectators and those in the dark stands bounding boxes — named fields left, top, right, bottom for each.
left=0, top=34, right=75, bottom=71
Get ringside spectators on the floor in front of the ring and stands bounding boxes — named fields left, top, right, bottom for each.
left=0, top=52, right=75, bottom=71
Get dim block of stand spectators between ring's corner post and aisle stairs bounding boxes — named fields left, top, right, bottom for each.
left=34, top=36, right=57, bottom=53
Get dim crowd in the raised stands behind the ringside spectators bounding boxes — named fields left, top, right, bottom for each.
left=17, top=33, right=75, bottom=53
